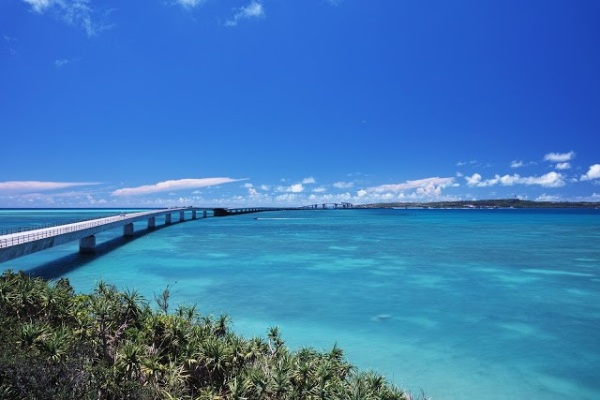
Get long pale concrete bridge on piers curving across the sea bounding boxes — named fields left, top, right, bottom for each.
left=0, top=203, right=352, bottom=263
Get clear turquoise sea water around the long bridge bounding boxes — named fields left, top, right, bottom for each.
left=0, top=209, right=600, bottom=400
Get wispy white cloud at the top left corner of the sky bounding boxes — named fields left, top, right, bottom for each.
left=22, top=0, right=110, bottom=36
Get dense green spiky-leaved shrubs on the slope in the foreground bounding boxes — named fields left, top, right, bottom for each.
left=0, top=271, right=418, bottom=400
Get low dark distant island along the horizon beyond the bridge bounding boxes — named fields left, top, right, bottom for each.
left=354, top=199, right=600, bottom=208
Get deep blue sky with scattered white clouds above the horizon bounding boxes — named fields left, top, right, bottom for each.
left=0, top=0, right=600, bottom=207
